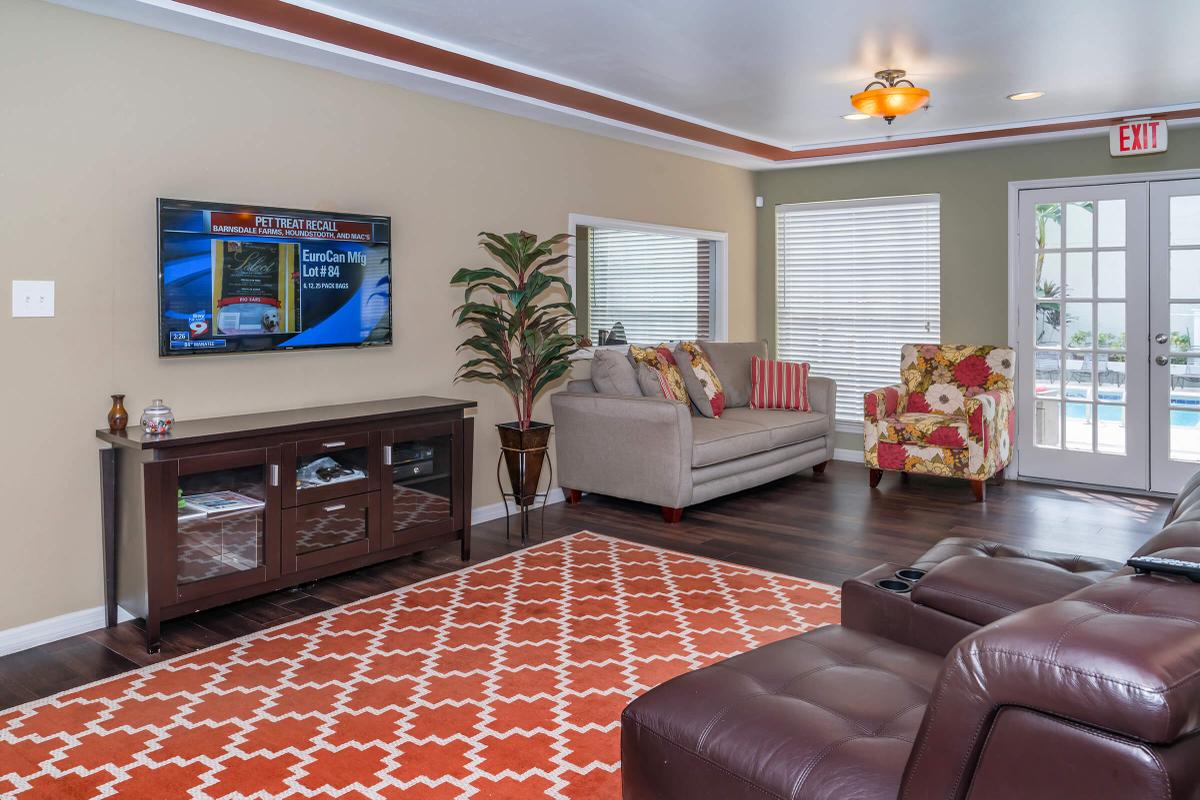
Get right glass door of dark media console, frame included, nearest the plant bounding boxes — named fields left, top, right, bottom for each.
left=383, top=421, right=463, bottom=546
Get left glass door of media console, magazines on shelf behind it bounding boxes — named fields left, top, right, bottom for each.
left=174, top=450, right=278, bottom=600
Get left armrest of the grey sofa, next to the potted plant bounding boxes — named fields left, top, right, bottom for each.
left=550, top=392, right=692, bottom=509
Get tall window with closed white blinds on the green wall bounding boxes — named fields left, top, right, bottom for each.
left=775, top=194, right=941, bottom=431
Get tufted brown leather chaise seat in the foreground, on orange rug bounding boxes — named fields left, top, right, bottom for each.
left=622, top=626, right=942, bottom=800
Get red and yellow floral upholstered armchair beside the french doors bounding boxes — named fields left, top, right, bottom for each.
left=863, top=344, right=1016, bottom=501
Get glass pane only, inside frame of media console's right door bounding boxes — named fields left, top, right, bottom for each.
left=391, top=435, right=454, bottom=530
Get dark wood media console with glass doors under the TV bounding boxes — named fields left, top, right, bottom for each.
left=96, top=397, right=475, bottom=652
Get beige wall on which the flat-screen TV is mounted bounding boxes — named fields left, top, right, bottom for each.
left=0, top=0, right=755, bottom=628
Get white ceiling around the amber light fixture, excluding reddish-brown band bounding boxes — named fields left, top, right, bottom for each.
left=49, top=0, right=1200, bottom=168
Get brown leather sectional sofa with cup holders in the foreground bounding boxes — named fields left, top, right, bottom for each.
left=622, top=475, right=1200, bottom=800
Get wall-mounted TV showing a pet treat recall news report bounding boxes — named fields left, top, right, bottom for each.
left=158, top=198, right=391, bottom=356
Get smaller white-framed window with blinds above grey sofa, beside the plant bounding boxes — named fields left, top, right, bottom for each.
left=588, top=227, right=716, bottom=344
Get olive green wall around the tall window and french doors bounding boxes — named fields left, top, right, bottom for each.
left=755, top=127, right=1200, bottom=449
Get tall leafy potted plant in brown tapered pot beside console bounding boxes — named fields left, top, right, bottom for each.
left=450, top=230, right=578, bottom=506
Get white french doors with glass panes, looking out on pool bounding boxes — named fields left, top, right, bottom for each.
left=1018, top=180, right=1200, bottom=492
